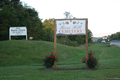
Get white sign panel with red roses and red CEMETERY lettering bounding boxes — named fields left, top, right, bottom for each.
left=56, top=19, right=86, bottom=35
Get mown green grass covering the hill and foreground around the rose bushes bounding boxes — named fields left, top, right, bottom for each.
left=0, top=40, right=120, bottom=80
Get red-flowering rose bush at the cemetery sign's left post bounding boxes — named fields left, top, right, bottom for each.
left=42, top=52, right=57, bottom=68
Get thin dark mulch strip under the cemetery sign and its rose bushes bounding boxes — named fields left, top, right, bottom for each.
left=40, top=68, right=97, bottom=71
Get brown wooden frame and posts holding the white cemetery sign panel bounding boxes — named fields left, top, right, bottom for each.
left=54, top=18, right=88, bottom=68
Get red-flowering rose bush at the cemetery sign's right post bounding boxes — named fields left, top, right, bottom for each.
left=81, top=50, right=100, bottom=68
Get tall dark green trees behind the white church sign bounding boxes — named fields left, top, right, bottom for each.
left=0, top=0, right=43, bottom=40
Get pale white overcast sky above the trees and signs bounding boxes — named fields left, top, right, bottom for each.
left=20, top=0, right=120, bottom=37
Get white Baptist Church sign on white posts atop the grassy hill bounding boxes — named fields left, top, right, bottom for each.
left=9, top=27, right=27, bottom=40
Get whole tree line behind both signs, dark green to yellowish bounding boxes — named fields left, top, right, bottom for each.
left=0, top=0, right=92, bottom=46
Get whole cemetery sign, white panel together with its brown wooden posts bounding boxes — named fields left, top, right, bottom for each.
left=54, top=18, right=88, bottom=68
